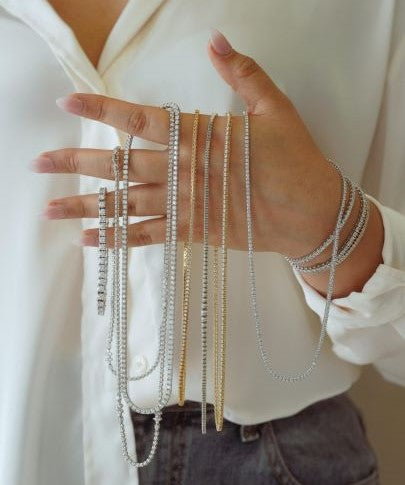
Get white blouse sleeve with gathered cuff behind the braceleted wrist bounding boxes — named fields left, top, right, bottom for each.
left=293, top=2, right=405, bottom=386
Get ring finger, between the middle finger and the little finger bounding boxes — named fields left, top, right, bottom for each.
left=43, top=184, right=167, bottom=219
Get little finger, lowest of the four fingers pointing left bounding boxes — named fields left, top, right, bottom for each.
left=79, top=217, right=166, bottom=248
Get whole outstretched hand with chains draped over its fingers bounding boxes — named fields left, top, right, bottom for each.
left=33, top=31, right=340, bottom=256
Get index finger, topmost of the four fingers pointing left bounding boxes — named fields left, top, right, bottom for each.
left=56, top=93, right=169, bottom=145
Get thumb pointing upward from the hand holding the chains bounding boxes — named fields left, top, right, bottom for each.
left=208, top=29, right=284, bottom=114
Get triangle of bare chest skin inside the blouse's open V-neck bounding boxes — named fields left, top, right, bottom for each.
left=48, top=0, right=127, bottom=68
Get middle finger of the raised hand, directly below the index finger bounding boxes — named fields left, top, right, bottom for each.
left=31, top=148, right=167, bottom=183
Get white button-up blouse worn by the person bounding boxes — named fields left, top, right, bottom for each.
left=0, top=0, right=405, bottom=485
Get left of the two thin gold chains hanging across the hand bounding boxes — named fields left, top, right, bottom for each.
left=179, top=109, right=200, bottom=406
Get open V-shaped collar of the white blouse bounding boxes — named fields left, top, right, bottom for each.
left=0, top=0, right=165, bottom=94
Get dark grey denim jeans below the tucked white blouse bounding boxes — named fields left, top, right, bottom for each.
left=132, top=393, right=379, bottom=485
